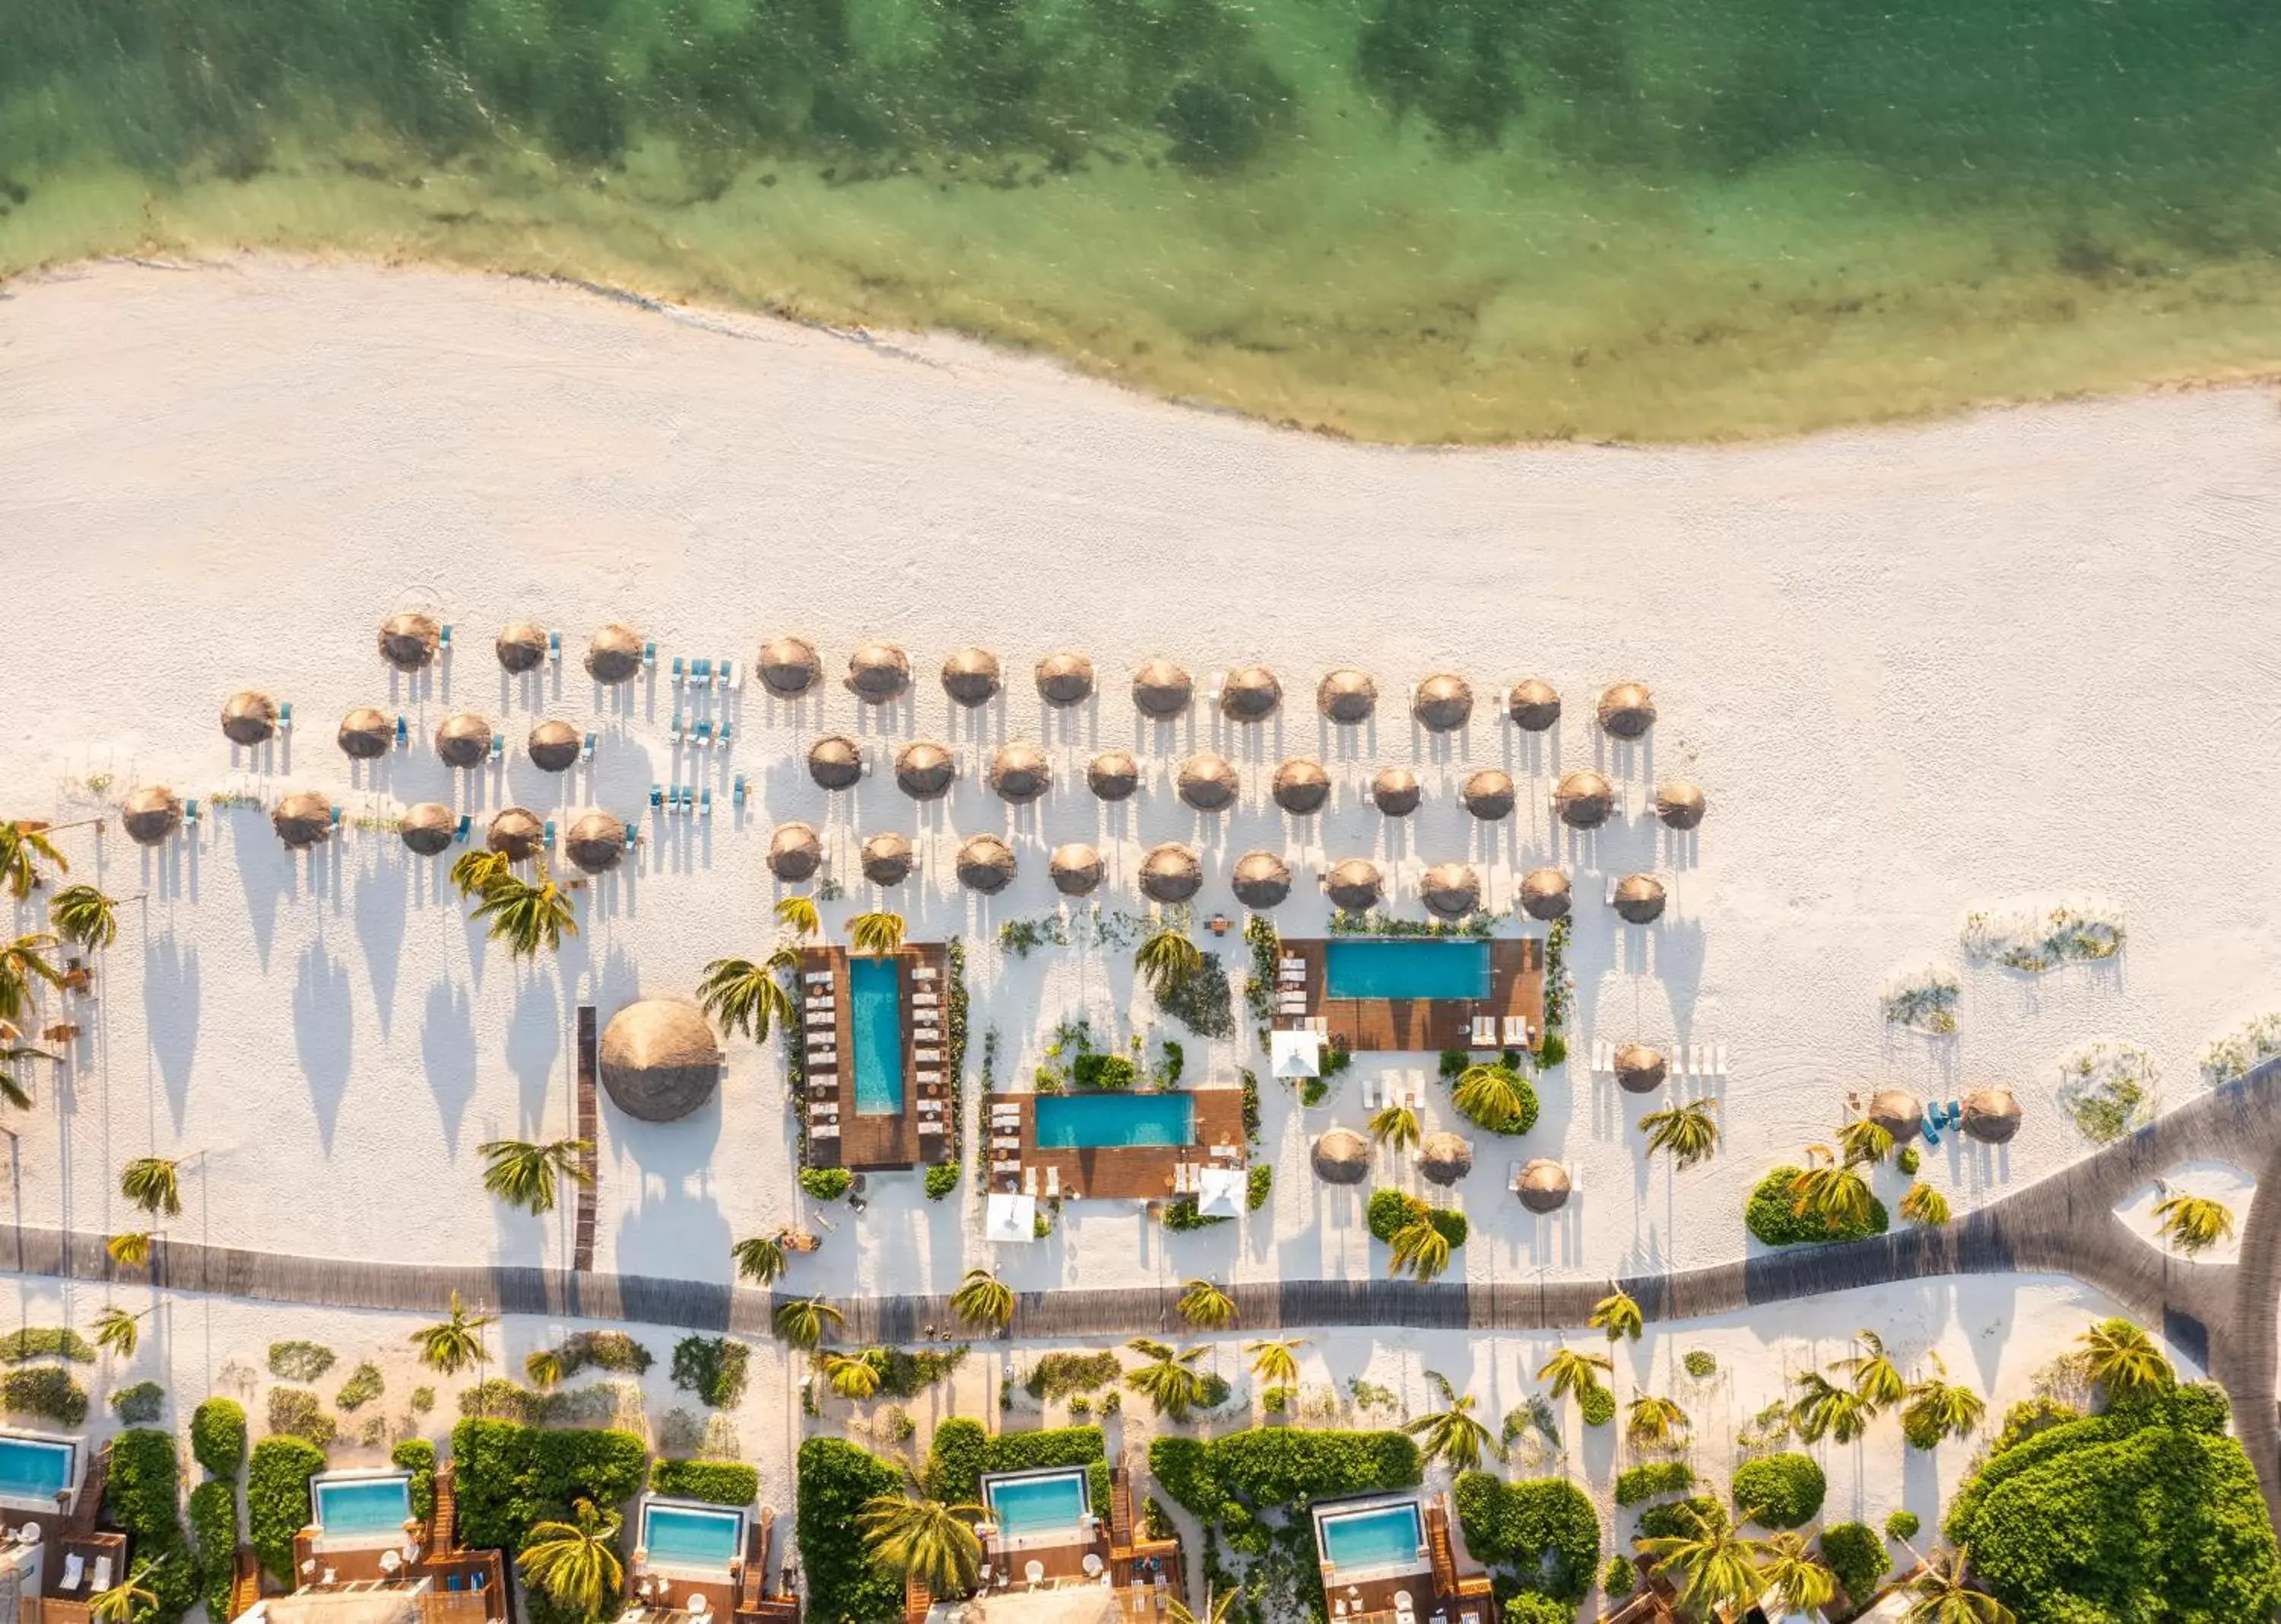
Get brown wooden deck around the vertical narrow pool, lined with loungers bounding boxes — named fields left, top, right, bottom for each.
left=798, top=942, right=956, bottom=1172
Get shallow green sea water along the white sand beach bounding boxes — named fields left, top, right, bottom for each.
left=0, top=0, right=2281, bottom=438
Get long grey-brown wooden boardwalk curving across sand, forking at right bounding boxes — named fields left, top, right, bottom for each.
left=17, top=1061, right=2281, bottom=1526
